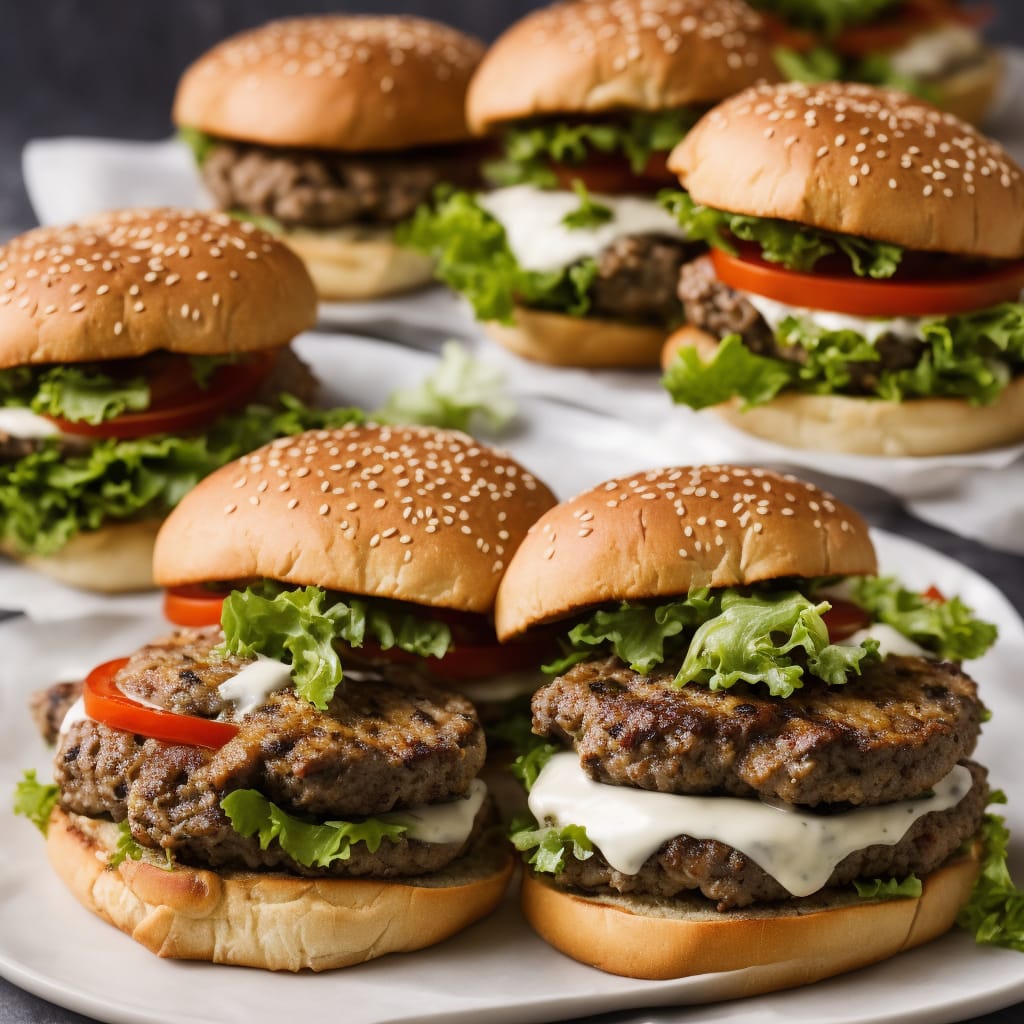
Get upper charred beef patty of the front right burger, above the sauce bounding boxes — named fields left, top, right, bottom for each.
left=532, top=656, right=982, bottom=806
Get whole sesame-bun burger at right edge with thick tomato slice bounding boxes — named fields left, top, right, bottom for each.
left=664, top=83, right=1024, bottom=456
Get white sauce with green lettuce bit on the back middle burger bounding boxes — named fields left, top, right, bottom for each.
left=478, top=185, right=685, bottom=270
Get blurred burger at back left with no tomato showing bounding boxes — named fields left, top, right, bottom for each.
left=173, top=14, right=483, bottom=299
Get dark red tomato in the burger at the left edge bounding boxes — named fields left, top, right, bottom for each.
left=47, top=351, right=278, bottom=440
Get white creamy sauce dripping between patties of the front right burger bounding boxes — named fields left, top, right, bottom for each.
left=529, top=753, right=971, bottom=896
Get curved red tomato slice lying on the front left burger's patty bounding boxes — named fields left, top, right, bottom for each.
left=82, top=657, right=239, bottom=750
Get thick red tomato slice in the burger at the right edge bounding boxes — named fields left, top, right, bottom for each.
left=711, top=249, right=1024, bottom=316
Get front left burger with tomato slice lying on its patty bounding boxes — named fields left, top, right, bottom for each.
left=14, top=426, right=554, bottom=971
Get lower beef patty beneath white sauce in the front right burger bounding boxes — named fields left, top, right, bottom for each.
left=554, top=762, right=988, bottom=910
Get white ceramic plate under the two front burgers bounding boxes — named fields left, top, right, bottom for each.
left=0, top=535, right=1024, bottom=1024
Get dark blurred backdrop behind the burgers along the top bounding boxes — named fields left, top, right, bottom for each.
left=0, top=0, right=1024, bottom=239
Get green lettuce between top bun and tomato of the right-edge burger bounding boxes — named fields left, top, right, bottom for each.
left=658, top=189, right=904, bottom=280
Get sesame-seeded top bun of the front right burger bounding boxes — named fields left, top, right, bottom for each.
left=495, top=466, right=878, bottom=640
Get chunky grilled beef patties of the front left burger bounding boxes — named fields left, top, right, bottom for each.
left=49, top=629, right=484, bottom=877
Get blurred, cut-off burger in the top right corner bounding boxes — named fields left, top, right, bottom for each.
left=752, top=0, right=1002, bottom=124
